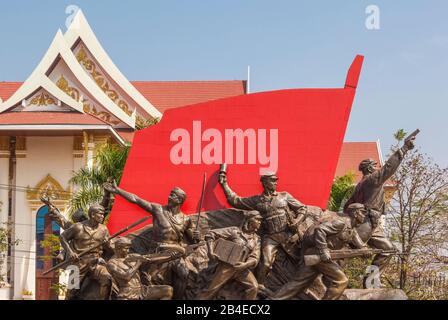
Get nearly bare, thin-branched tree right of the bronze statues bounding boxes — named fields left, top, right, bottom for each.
left=388, top=150, right=448, bottom=294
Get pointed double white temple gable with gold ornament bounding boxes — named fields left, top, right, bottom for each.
left=0, top=10, right=162, bottom=129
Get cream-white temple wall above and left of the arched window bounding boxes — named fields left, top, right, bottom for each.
left=14, top=137, right=74, bottom=299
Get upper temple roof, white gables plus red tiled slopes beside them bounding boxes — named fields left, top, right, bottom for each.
left=0, top=10, right=246, bottom=131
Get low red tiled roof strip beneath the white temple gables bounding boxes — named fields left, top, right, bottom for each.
left=0, top=112, right=106, bottom=125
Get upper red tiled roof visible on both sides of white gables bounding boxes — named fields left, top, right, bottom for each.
left=0, top=80, right=246, bottom=113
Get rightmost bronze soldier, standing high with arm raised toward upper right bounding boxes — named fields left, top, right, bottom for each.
left=344, top=130, right=418, bottom=285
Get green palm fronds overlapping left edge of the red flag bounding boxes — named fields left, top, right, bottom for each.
left=69, top=143, right=131, bottom=215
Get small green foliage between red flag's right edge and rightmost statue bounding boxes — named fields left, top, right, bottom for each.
left=327, top=172, right=355, bottom=212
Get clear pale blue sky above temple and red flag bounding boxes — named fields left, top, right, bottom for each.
left=0, top=0, right=448, bottom=166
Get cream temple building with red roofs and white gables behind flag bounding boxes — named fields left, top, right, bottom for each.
left=0, top=11, right=382, bottom=299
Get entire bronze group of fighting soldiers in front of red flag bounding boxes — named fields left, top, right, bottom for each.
left=42, top=135, right=415, bottom=300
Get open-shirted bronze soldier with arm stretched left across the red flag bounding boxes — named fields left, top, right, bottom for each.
left=104, top=183, right=199, bottom=299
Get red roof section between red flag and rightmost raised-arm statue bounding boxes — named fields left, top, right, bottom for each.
left=335, top=142, right=381, bottom=182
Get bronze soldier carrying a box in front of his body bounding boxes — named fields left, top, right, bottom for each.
left=198, top=211, right=262, bottom=300
